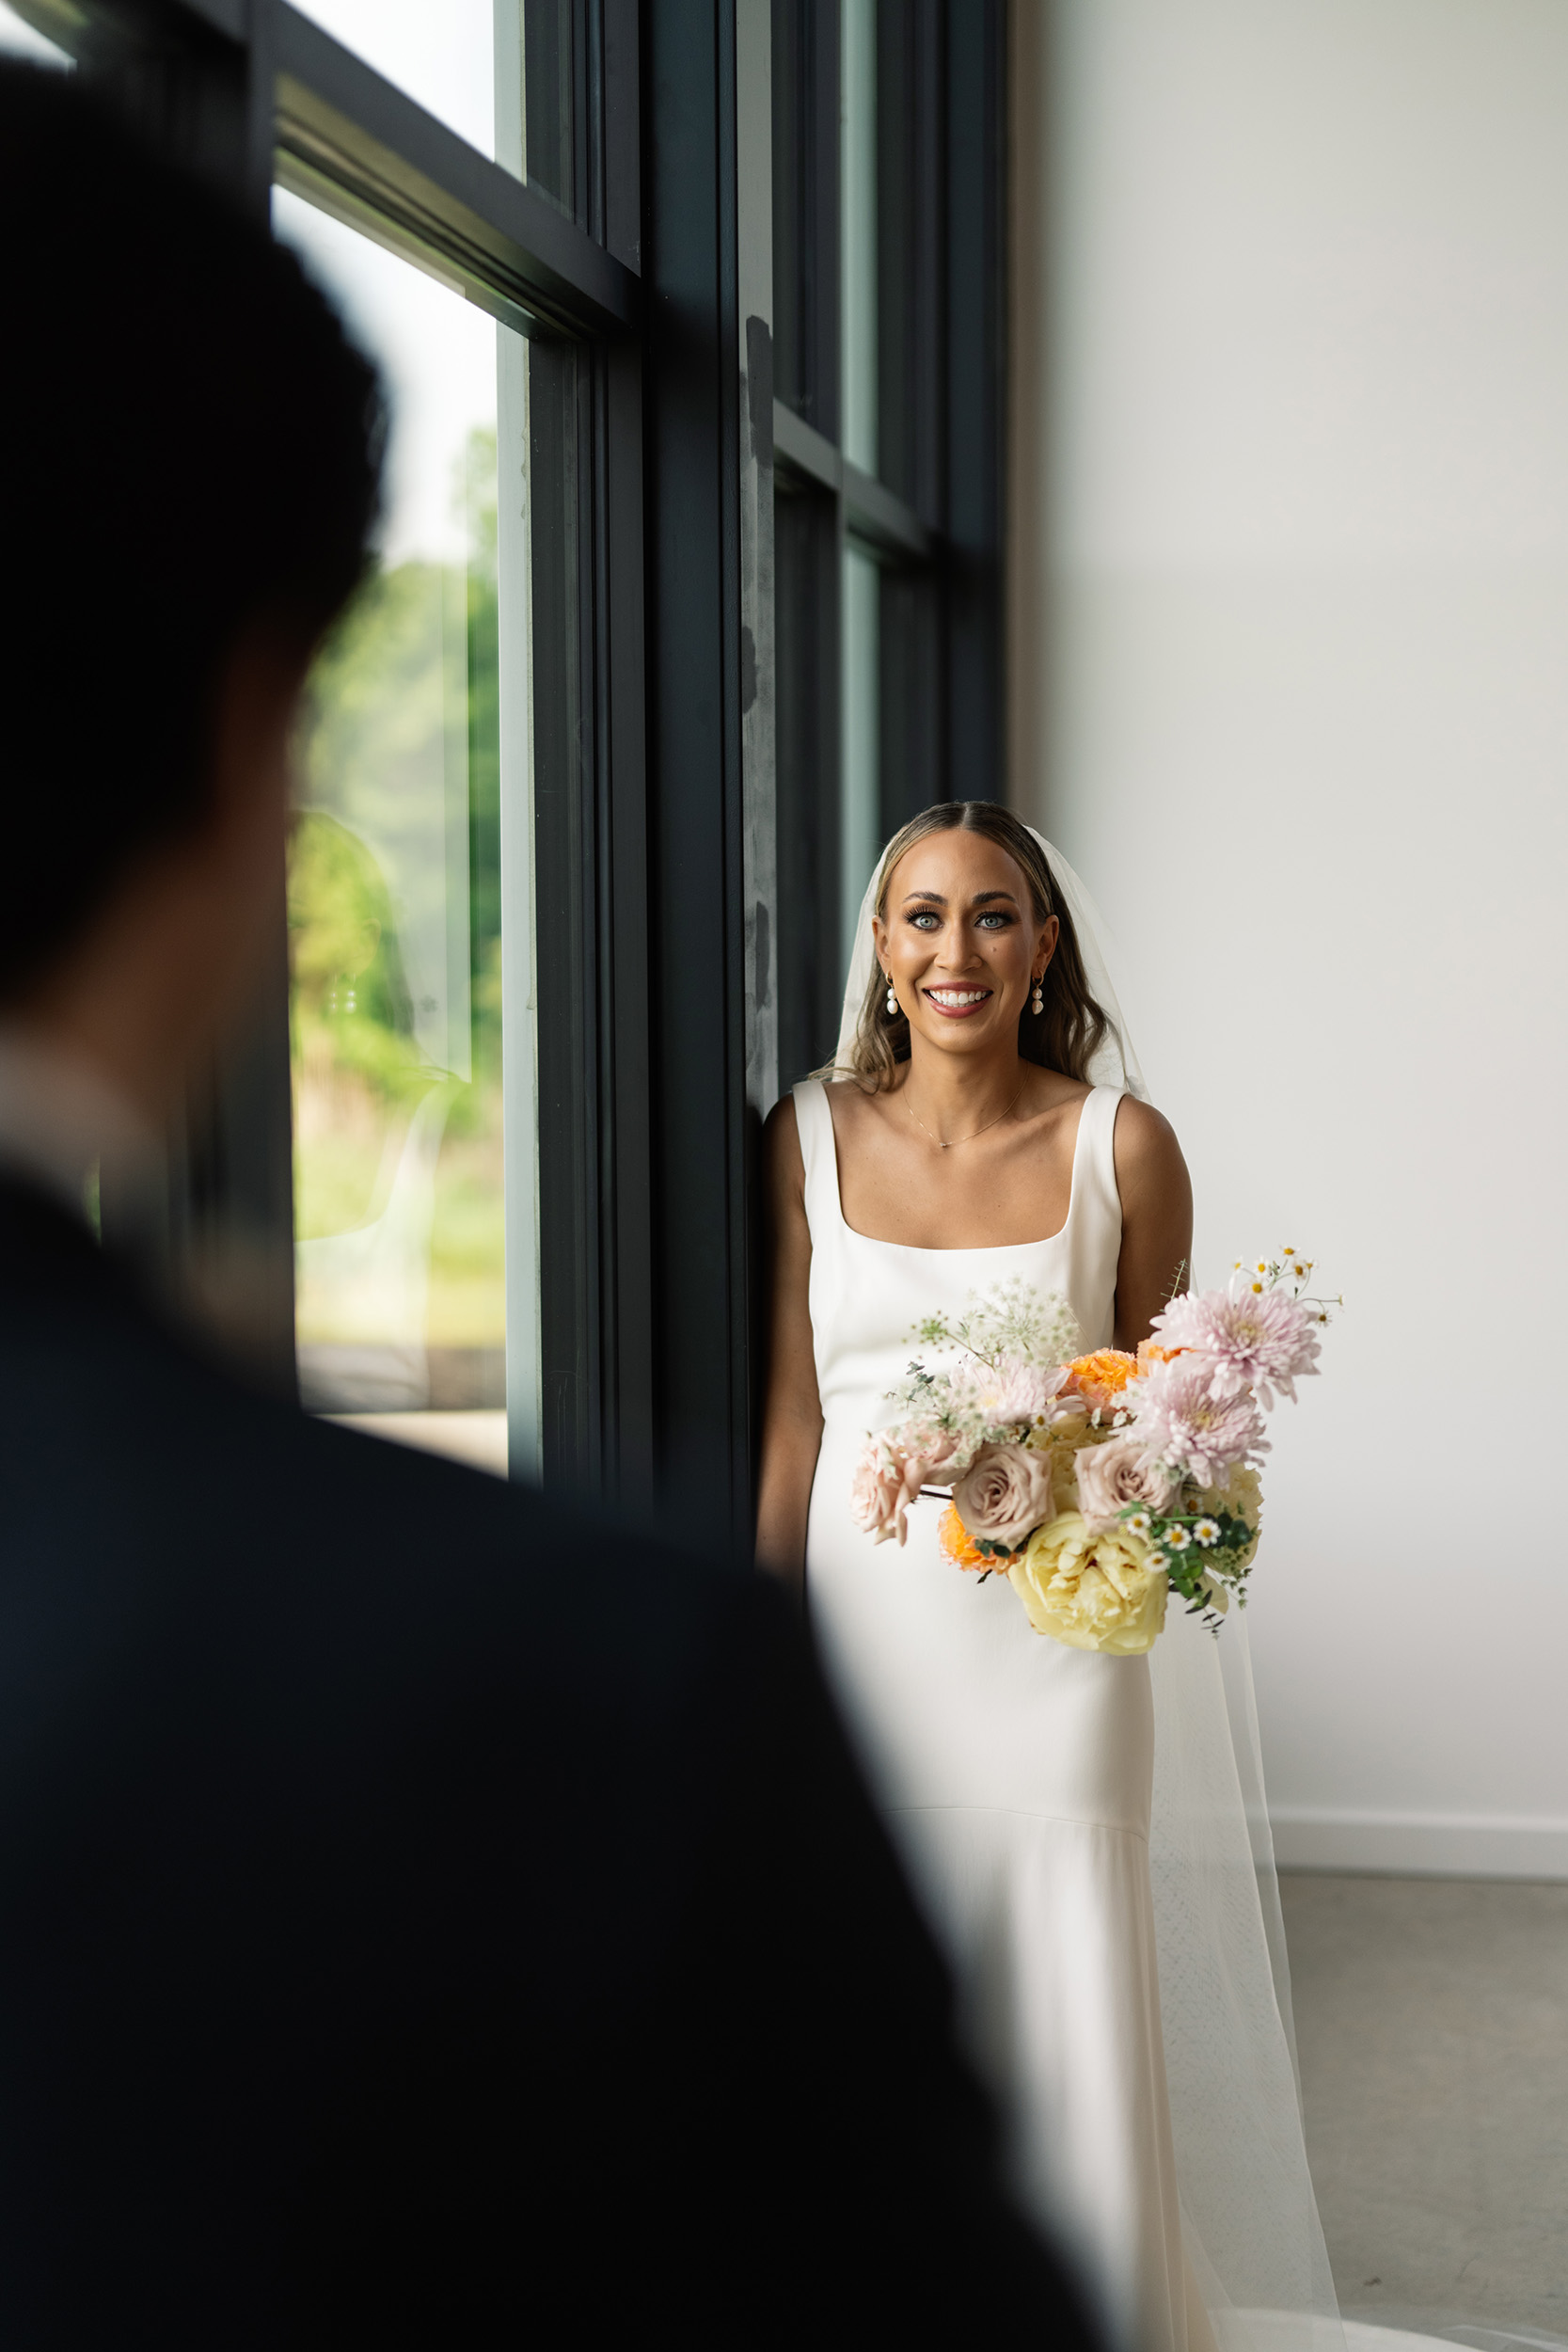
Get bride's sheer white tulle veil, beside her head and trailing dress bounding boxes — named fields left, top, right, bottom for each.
left=834, top=828, right=1345, bottom=2352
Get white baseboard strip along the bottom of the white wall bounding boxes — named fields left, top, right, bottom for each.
left=1270, top=1806, right=1568, bottom=1880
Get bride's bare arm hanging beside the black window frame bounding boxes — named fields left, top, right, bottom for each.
left=757, top=1094, right=823, bottom=1585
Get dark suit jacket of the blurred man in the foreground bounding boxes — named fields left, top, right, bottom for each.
left=0, top=1185, right=1090, bottom=2352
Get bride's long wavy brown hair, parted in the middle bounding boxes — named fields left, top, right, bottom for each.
left=814, top=800, right=1117, bottom=1094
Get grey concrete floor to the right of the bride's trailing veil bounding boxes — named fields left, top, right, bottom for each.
left=1281, top=1875, right=1568, bottom=2352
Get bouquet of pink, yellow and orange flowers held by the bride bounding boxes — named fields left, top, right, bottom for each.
left=851, top=1249, right=1328, bottom=1656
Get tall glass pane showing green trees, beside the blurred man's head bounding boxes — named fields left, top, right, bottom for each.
left=273, top=191, right=536, bottom=1468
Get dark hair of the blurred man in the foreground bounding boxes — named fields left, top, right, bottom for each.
left=0, top=64, right=383, bottom=997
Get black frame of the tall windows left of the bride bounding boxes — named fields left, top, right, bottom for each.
left=16, top=0, right=1004, bottom=1557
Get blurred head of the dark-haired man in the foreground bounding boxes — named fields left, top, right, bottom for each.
left=0, top=64, right=383, bottom=1113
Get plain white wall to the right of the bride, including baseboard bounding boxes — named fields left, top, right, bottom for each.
left=1013, top=0, right=1568, bottom=1877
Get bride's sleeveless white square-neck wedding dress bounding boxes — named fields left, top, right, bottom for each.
left=795, top=1080, right=1189, bottom=2352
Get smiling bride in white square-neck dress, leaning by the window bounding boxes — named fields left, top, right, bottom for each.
left=757, top=803, right=1204, bottom=2352
